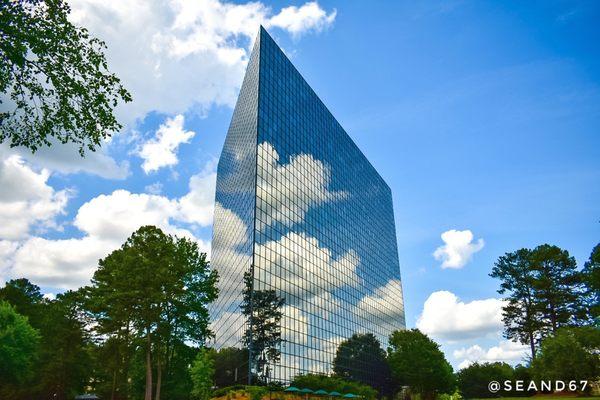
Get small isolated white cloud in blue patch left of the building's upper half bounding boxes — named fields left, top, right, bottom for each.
left=139, top=114, right=196, bottom=174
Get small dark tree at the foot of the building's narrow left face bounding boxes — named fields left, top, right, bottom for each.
left=212, top=347, right=248, bottom=388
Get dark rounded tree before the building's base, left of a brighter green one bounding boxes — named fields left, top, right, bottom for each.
left=333, top=333, right=392, bottom=395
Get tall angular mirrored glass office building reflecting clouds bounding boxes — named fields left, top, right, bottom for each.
left=211, top=28, right=405, bottom=382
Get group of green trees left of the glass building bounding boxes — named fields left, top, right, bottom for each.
left=0, top=226, right=217, bottom=400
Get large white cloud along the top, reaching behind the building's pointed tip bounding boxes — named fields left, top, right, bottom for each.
left=70, top=0, right=335, bottom=124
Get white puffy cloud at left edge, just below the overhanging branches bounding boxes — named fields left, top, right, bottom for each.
left=0, top=155, right=69, bottom=240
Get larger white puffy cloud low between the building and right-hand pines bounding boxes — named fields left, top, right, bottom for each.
left=417, top=291, right=504, bottom=341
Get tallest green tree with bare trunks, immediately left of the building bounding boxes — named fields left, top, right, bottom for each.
left=87, top=226, right=217, bottom=400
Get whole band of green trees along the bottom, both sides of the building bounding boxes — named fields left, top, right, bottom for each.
left=0, top=226, right=600, bottom=400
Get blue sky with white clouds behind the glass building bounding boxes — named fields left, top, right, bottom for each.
left=0, top=0, right=600, bottom=367
